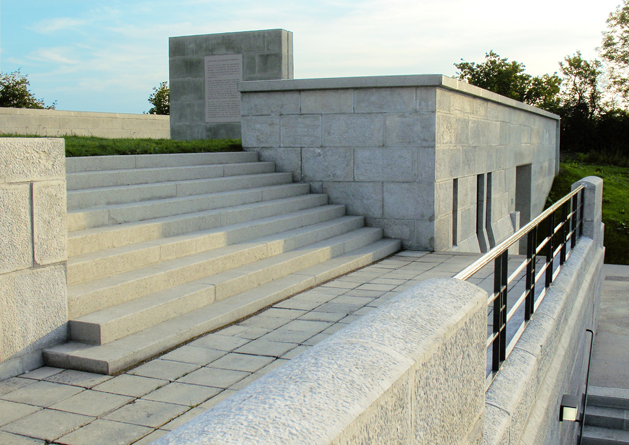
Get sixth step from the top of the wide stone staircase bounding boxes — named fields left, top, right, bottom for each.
left=67, top=205, right=345, bottom=285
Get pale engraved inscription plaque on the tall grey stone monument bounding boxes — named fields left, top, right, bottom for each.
left=205, top=54, right=242, bottom=123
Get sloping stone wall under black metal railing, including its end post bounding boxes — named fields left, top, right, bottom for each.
left=485, top=177, right=605, bottom=445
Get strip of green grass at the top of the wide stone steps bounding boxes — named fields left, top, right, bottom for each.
left=0, top=135, right=242, bottom=157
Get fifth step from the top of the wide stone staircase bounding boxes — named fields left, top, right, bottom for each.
left=68, top=193, right=332, bottom=257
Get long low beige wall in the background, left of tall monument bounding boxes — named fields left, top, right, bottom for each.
left=0, top=108, right=170, bottom=139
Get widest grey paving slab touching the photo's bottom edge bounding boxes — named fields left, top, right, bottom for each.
left=58, top=419, right=153, bottom=445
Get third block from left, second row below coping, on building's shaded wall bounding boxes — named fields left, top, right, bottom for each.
left=323, top=114, right=384, bottom=147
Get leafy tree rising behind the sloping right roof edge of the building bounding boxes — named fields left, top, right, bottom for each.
left=454, top=51, right=561, bottom=112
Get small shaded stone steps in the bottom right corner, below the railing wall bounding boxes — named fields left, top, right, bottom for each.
left=582, top=386, right=629, bottom=445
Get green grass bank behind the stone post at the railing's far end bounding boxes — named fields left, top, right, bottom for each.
left=548, top=161, right=629, bottom=264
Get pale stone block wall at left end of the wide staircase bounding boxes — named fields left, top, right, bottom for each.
left=0, top=138, right=68, bottom=380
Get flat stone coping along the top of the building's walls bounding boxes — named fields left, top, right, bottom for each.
left=238, top=74, right=560, bottom=121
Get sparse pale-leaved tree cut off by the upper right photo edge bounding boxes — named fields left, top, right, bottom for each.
left=600, top=0, right=629, bottom=103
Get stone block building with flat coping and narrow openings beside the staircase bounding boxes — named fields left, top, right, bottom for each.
left=239, top=75, right=558, bottom=252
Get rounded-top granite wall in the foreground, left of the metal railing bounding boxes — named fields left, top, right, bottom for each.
left=155, top=279, right=487, bottom=445
